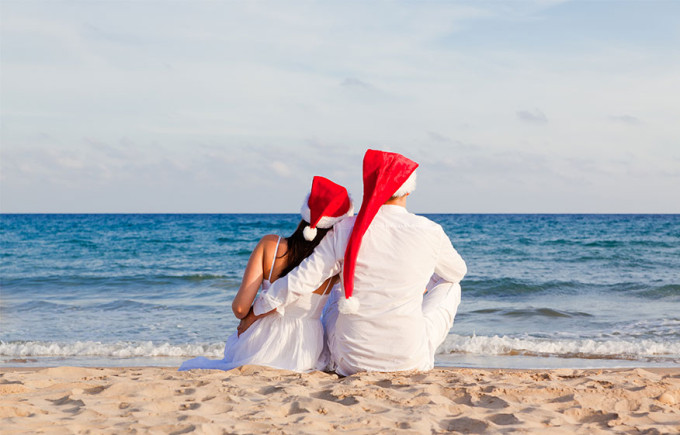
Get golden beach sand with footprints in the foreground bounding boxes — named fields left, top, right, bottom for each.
left=0, top=366, right=680, bottom=434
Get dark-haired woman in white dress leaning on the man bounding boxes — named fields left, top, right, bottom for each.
left=179, top=177, right=354, bottom=372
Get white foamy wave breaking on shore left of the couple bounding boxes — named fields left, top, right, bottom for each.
left=0, top=341, right=224, bottom=358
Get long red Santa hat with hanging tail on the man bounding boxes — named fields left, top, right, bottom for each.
left=338, top=150, right=418, bottom=314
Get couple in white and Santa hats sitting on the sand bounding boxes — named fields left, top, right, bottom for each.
left=180, top=150, right=467, bottom=376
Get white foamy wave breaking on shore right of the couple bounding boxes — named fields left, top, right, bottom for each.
left=439, top=334, right=680, bottom=363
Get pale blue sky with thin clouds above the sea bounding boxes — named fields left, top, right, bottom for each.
left=0, top=0, right=680, bottom=213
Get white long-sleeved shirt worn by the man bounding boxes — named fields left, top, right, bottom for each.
left=254, top=205, right=467, bottom=375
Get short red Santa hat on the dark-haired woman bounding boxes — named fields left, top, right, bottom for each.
left=300, top=176, right=354, bottom=242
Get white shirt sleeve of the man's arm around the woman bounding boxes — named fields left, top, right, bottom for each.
left=253, top=230, right=344, bottom=316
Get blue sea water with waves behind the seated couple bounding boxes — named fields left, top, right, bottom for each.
left=0, top=214, right=680, bottom=368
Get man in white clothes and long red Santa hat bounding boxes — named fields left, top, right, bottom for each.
left=254, top=150, right=467, bottom=375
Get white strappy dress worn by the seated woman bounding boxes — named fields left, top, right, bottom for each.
left=179, top=237, right=330, bottom=372
